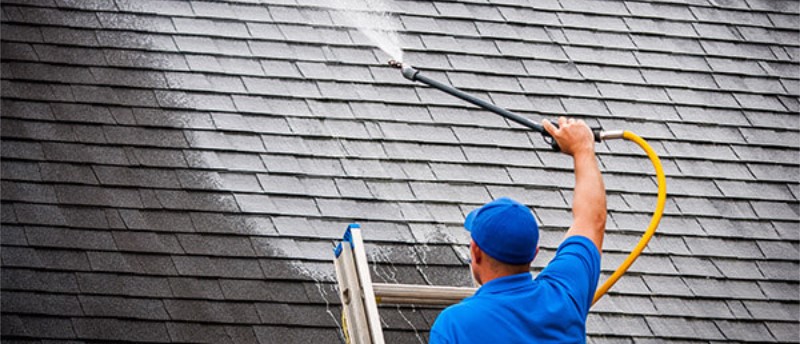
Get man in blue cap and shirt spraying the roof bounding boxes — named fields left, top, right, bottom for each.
left=430, top=117, right=606, bottom=344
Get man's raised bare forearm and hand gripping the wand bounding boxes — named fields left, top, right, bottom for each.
left=542, top=117, right=606, bottom=252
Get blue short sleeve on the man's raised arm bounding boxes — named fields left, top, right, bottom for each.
left=536, top=235, right=600, bottom=316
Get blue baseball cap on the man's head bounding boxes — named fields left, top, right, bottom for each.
left=464, top=197, right=539, bottom=264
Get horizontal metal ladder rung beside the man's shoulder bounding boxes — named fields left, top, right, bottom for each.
left=373, top=283, right=478, bottom=305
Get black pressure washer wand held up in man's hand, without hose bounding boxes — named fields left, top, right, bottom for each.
left=389, top=60, right=602, bottom=151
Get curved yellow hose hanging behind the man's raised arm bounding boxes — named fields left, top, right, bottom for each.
left=592, top=130, right=667, bottom=305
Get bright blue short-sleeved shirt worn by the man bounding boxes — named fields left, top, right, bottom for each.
left=430, top=236, right=600, bottom=344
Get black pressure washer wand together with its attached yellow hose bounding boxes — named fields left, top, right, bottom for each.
left=389, top=60, right=667, bottom=304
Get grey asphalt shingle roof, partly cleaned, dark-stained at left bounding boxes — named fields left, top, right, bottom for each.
left=0, top=0, right=800, bottom=343
